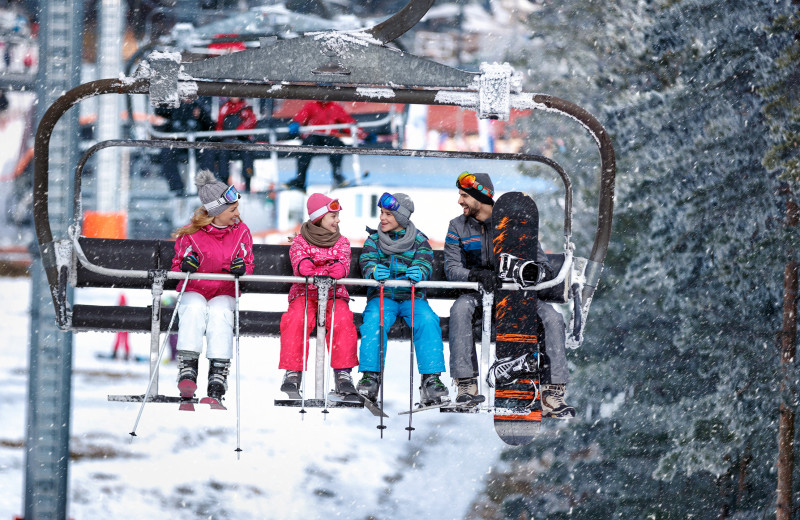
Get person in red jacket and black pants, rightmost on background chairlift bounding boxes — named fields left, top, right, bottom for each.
left=286, top=101, right=372, bottom=191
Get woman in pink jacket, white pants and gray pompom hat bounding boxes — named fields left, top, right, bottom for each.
left=172, top=170, right=254, bottom=403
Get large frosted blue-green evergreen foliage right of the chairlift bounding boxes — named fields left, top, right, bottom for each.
left=472, top=0, right=797, bottom=518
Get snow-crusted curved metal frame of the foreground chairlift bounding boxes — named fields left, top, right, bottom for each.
left=33, top=0, right=616, bottom=400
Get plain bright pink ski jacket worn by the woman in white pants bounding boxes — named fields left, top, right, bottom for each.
left=171, top=222, right=255, bottom=300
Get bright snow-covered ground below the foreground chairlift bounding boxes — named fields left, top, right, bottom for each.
left=0, top=278, right=504, bottom=520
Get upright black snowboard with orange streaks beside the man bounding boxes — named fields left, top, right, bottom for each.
left=489, top=192, right=543, bottom=446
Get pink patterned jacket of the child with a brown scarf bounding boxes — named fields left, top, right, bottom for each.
left=289, top=235, right=350, bottom=302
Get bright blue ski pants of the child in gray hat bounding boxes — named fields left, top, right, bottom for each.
left=358, top=297, right=445, bottom=374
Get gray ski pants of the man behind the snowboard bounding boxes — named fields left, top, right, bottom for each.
left=449, top=293, right=569, bottom=385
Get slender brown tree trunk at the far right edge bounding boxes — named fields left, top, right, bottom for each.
left=775, top=190, right=800, bottom=520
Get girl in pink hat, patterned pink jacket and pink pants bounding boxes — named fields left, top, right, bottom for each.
left=278, top=193, right=358, bottom=400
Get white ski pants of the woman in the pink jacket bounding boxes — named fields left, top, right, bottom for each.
left=178, top=291, right=236, bottom=359
